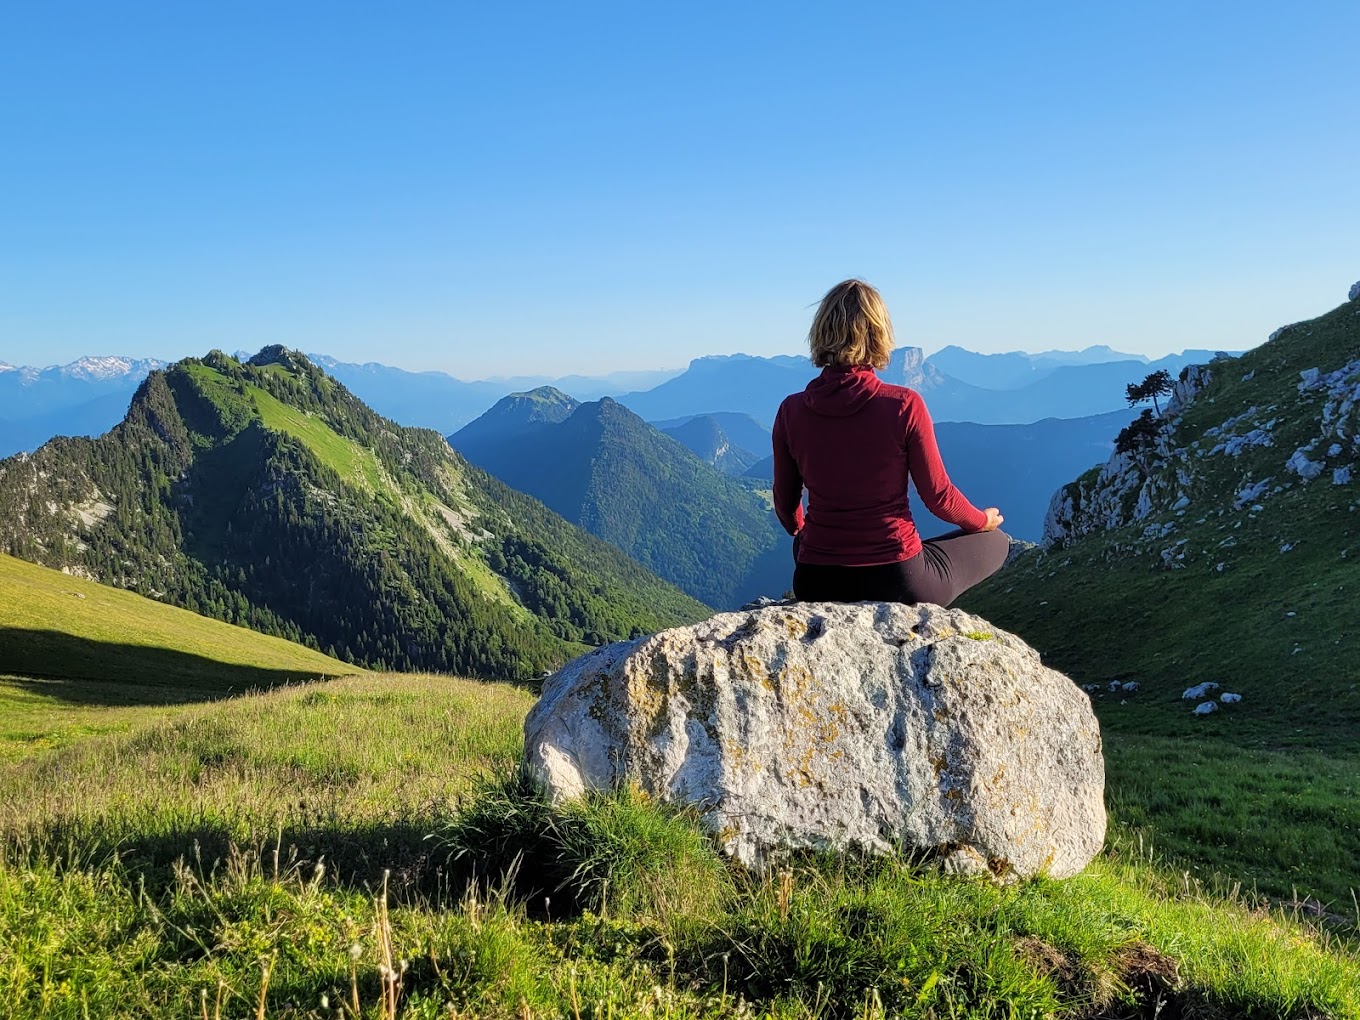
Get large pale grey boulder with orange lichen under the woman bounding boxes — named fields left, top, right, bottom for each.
left=525, top=602, right=1106, bottom=879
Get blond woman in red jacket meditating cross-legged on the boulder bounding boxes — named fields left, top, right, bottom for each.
left=774, top=280, right=1010, bottom=605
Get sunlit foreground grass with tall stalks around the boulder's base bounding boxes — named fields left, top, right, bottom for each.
left=0, top=676, right=1360, bottom=1020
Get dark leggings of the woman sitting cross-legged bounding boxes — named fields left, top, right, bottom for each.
left=793, top=530, right=1010, bottom=605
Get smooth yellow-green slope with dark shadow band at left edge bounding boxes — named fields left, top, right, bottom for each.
left=0, top=555, right=363, bottom=760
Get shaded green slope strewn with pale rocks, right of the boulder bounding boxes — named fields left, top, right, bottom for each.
left=962, top=291, right=1360, bottom=904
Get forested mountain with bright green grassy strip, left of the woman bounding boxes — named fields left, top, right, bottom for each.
left=0, top=347, right=704, bottom=677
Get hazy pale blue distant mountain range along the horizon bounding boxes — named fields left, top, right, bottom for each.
left=0, top=347, right=1245, bottom=459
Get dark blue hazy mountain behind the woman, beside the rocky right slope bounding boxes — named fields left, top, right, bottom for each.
left=747, top=409, right=1133, bottom=541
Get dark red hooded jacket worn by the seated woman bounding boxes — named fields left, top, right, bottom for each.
left=772, top=364, right=987, bottom=567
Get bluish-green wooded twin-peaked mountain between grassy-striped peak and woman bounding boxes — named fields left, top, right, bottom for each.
left=449, top=390, right=792, bottom=608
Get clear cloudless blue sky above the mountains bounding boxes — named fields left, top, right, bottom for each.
left=0, top=0, right=1360, bottom=378
